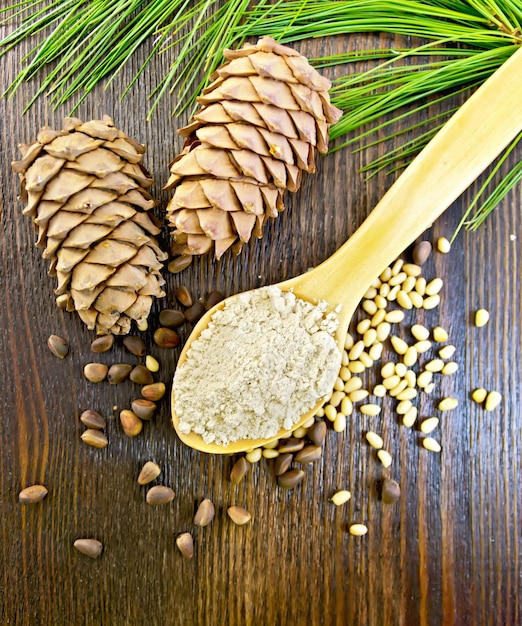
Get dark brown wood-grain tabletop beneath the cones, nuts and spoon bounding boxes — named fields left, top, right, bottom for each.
left=0, top=15, right=522, bottom=626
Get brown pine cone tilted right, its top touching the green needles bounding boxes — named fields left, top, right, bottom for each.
left=165, top=37, right=342, bottom=268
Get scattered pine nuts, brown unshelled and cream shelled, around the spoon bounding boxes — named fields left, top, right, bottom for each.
left=19, top=238, right=502, bottom=558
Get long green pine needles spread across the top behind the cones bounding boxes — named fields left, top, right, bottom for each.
left=0, top=0, right=522, bottom=229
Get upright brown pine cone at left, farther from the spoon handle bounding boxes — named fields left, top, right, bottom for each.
left=12, top=116, right=167, bottom=334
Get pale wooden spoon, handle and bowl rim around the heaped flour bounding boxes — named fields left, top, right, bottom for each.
left=172, top=48, right=522, bottom=454
